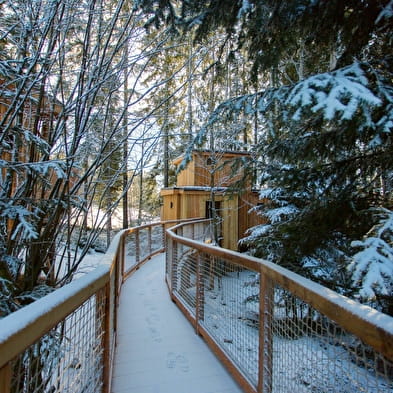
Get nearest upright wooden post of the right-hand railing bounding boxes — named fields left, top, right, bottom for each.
left=257, top=271, right=273, bottom=393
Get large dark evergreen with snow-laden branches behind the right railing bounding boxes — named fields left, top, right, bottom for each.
left=137, top=0, right=393, bottom=313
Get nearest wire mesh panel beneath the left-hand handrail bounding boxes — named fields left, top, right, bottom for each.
left=11, top=293, right=105, bottom=393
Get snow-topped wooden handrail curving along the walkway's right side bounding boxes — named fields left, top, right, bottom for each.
left=167, top=219, right=393, bottom=361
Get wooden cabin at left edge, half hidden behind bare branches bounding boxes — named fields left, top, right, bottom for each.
left=0, top=68, right=63, bottom=281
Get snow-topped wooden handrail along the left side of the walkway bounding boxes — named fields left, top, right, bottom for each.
left=0, top=220, right=204, bottom=392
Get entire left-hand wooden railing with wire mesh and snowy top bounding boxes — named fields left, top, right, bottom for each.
left=0, top=221, right=187, bottom=393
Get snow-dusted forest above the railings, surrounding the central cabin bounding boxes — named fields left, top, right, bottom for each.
left=0, top=0, right=393, bottom=316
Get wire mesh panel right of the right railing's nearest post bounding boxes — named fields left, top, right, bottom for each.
left=268, top=286, right=393, bottom=393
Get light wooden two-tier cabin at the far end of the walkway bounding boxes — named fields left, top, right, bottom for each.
left=161, top=151, right=262, bottom=250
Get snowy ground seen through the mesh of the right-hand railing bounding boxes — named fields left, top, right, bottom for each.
left=189, top=271, right=393, bottom=393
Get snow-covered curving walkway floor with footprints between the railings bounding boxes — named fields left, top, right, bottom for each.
left=112, top=254, right=242, bottom=393
